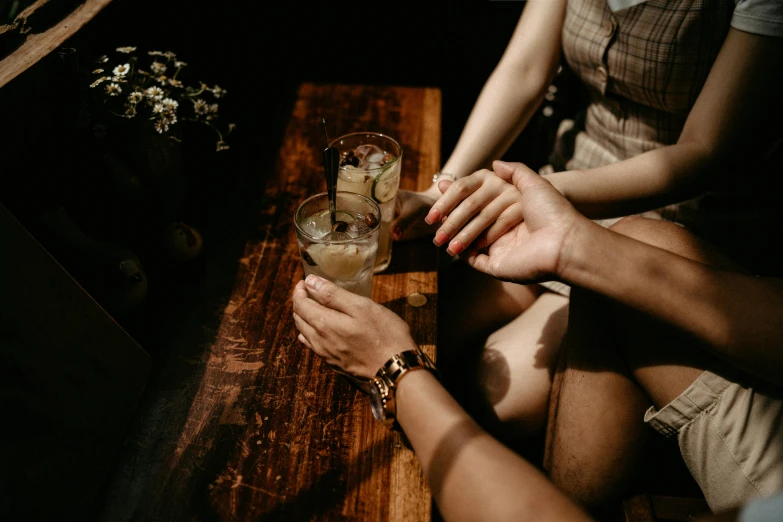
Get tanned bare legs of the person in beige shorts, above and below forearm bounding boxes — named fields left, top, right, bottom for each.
left=545, top=218, right=748, bottom=514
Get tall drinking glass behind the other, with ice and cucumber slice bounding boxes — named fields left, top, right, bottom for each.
left=329, top=132, right=402, bottom=273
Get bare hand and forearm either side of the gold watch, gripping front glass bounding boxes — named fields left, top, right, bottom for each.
left=293, top=275, right=589, bottom=522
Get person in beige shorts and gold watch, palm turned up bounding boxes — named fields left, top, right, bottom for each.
left=292, top=162, right=783, bottom=521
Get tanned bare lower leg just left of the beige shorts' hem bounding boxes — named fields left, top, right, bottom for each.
left=544, top=288, right=651, bottom=515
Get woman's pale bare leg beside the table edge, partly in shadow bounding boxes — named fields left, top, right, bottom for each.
left=438, top=255, right=567, bottom=451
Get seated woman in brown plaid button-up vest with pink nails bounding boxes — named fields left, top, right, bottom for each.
left=392, top=0, right=783, bottom=460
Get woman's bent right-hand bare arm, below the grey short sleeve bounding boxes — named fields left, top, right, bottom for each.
left=547, top=29, right=783, bottom=218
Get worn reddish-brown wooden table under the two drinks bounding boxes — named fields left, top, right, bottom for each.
left=101, top=84, right=441, bottom=522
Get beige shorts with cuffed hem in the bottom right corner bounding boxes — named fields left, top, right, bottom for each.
left=644, top=367, right=783, bottom=512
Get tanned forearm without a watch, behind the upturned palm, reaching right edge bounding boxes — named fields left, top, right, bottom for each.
left=558, top=220, right=783, bottom=385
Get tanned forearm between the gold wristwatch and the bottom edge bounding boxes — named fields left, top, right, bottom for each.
left=396, top=371, right=589, bottom=522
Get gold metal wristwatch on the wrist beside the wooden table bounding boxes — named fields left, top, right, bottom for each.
left=369, top=348, right=439, bottom=428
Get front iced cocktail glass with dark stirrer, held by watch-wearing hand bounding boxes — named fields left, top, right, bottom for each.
left=294, top=191, right=381, bottom=297
